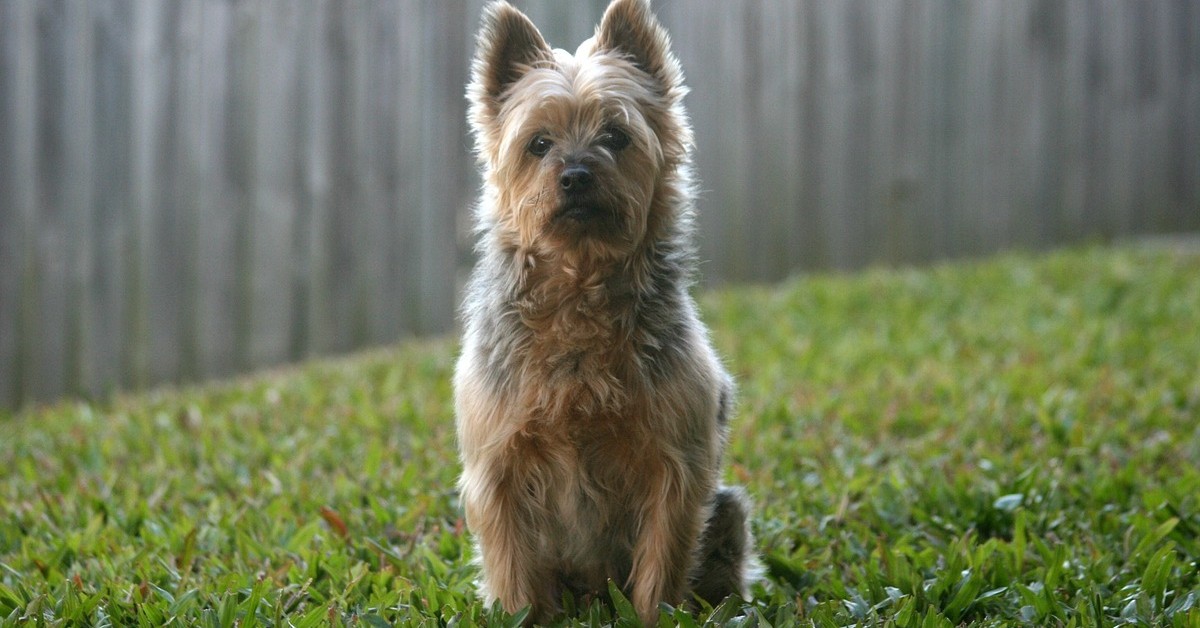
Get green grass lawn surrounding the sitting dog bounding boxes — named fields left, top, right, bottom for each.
left=0, top=249, right=1200, bottom=627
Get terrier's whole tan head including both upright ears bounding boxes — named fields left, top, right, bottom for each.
left=469, top=0, right=691, bottom=258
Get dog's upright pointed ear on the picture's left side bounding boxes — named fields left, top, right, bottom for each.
left=470, top=0, right=553, bottom=122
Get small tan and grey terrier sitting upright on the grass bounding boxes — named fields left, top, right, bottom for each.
left=454, top=0, right=757, bottom=624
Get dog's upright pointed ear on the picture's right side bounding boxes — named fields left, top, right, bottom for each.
left=595, top=0, right=683, bottom=91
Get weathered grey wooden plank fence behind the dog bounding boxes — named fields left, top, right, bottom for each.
left=0, top=0, right=1200, bottom=407
